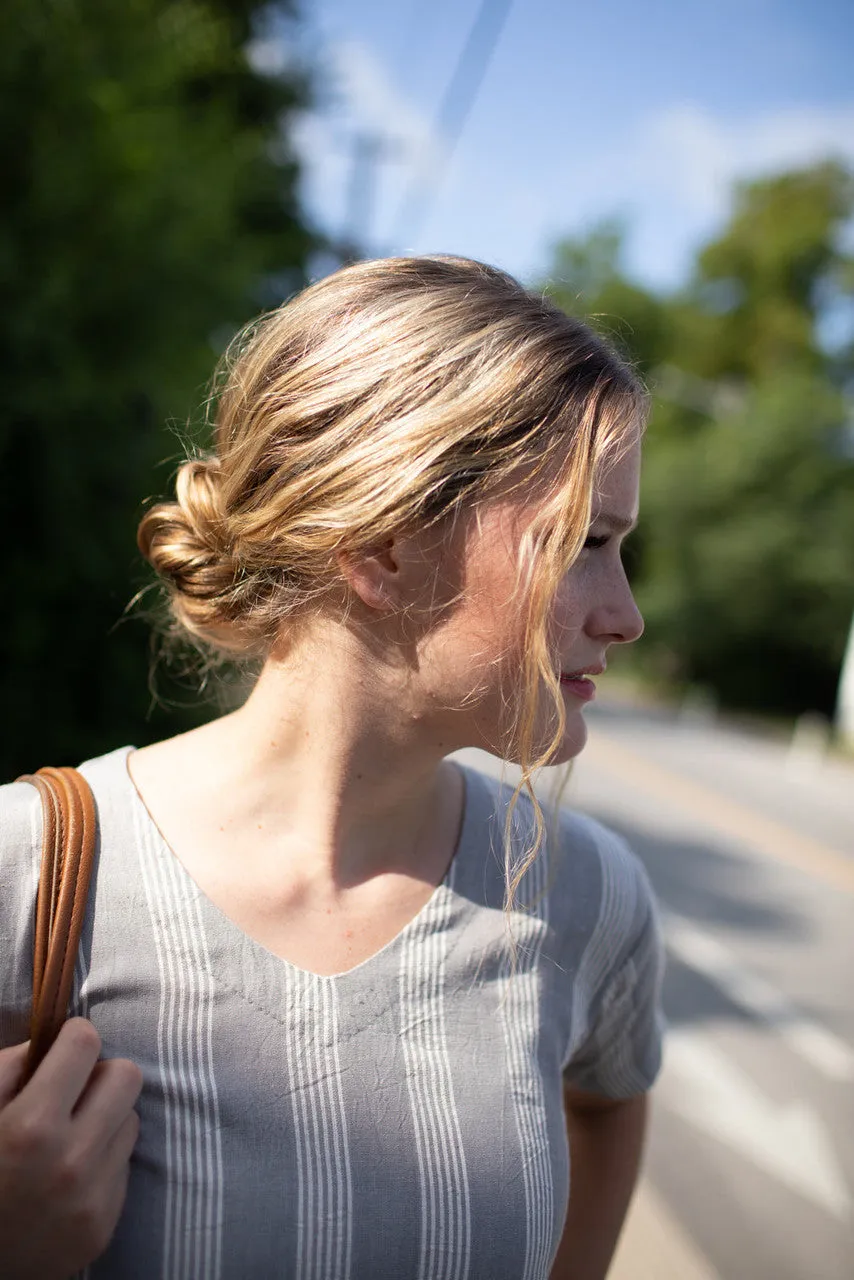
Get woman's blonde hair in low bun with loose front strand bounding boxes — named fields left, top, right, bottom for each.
left=138, top=256, right=647, bottom=910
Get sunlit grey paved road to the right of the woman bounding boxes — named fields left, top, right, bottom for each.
left=450, top=701, right=854, bottom=1280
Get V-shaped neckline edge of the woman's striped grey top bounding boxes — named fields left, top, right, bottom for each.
left=122, top=746, right=475, bottom=983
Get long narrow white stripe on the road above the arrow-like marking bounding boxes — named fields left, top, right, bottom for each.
left=662, top=911, right=854, bottom=1082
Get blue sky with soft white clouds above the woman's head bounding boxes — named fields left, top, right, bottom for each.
left=256, top=0, right=854, bottom=288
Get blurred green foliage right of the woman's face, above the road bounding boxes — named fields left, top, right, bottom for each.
left=551, top=163, right=854, bottom=713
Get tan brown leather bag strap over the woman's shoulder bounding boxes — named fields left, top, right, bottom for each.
left=17, top=767, right=97, bottom=1084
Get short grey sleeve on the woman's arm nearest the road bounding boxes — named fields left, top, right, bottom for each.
left=563, top=855, right=665, bottom=1098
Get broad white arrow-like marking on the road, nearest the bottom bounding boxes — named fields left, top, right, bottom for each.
left=661, top=1028, right=851, bottom=1221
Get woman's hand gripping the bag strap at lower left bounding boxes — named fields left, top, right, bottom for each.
left=0, top=1018, right=142, bottom=1280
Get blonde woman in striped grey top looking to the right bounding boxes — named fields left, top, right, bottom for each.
left=0, top=257, right=662, bottom=1280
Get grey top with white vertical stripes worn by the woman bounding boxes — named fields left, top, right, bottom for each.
left=0, top=748, right=663, bottom=1280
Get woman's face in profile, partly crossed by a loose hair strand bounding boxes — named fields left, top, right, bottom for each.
left=429, top=443, right=643, bottom=764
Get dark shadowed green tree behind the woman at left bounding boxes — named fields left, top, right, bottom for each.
left=0, top=0, right=314, bottom=777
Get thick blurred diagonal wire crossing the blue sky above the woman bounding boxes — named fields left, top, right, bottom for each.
left=392, top=0, right=512, bottom=244
